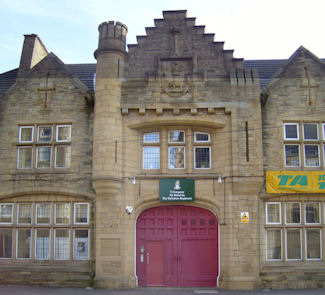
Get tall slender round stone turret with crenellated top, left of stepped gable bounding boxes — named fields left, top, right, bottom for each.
left=93, top=21, right=127, bottom=197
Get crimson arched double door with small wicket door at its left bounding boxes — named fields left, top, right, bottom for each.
left=136, top=206, right=219, bottom=287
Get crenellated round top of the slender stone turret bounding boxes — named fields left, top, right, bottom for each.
left=94, top=21, right=128, bottom=59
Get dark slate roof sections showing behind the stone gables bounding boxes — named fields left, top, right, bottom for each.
left=0, top=59, right=325, bottom=94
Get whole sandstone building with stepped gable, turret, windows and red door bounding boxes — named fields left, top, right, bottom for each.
left=0, top=11, right=325, bottom=289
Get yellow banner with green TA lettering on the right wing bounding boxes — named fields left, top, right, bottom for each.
left=266, top=171, right=325, bottom=194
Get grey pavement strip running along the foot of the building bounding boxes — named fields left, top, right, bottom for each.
left=0, top=285, right=325, bottom=295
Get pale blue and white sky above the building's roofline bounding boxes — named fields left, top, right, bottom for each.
left=0, top=0, right=325, bottom=73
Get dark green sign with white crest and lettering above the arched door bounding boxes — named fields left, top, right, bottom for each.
left=159, top=178, right=195, bottom=202
